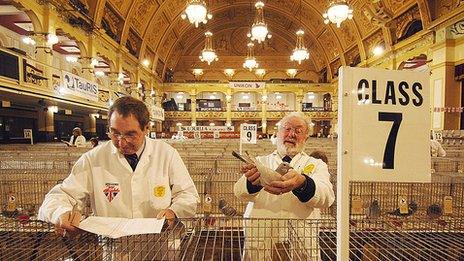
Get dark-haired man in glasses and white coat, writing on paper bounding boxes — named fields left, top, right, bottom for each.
left=39, top=96, right=198, bottom=234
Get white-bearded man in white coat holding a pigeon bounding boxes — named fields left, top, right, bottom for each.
left=234, top=112, right=335, bottom=260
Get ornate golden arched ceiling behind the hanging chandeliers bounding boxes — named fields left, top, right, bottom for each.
left=16, top=0, right=464, bottom=78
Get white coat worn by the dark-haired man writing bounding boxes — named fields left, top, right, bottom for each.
left=38, top=137, right=199, bottom=223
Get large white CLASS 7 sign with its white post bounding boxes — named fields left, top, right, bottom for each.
left=337, top=67, right=431, bottom=260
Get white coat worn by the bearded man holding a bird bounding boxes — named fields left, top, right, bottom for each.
left=234, top=151, right=335, bottom=260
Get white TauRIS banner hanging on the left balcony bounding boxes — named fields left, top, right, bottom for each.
left=61, top=71, right=98, bottom=101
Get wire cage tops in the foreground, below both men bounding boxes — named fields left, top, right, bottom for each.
left=0, top=215, right=464, bottom=261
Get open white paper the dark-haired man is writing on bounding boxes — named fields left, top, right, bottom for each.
left=79, top=216, right=164, bottom=238
